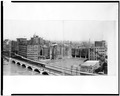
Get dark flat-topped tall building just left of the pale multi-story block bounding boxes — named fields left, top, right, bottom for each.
left=17, top=38, right=27, bottom=57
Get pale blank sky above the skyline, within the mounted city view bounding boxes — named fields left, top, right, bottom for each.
left=4, top=20, right=116, bottom=41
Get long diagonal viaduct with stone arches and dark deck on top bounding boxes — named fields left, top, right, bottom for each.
left=3, top=56, right=80, bottom=76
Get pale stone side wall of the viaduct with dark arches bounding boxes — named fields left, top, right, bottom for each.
left=9, top=58, right=60, bottom=75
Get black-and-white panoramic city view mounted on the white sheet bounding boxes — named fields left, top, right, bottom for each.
left=3, top=20, right=109, bottom=76
